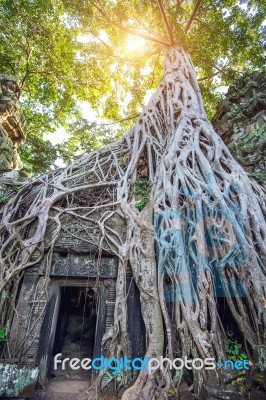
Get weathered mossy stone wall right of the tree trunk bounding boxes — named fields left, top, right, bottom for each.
left=212, top=72, right=266, bottom=183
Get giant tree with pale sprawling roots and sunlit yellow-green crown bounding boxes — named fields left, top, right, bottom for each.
left=0, top=0, right=266, bottom=400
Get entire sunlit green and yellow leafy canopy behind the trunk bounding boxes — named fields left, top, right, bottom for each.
left=0, top=0, right=266, bottom=172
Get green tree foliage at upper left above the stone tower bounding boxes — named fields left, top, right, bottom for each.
left=0, top=0, right=109, bottom=173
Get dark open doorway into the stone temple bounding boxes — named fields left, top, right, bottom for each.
left=50, top=286, right=97, bottom=380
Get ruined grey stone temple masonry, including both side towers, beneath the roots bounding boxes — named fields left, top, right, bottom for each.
left=0, top=75, right=266, bottom=400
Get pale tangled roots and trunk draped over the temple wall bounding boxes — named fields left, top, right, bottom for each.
left=0, top=48, right=266, bottom=400
